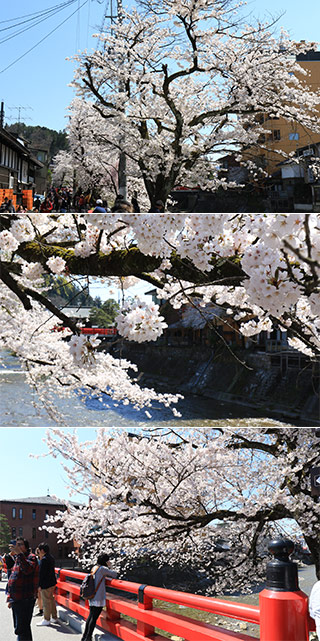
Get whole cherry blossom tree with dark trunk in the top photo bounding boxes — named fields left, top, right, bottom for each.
left=70, top=0, right=319, bottom=205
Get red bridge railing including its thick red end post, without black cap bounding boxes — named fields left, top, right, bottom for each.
left=56, top=569, right=315, bottom=641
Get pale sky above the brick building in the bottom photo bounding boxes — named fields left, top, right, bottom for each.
left=0, top=427, right=121, bottom=502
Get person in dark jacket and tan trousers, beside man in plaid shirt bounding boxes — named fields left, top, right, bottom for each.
left=37, top=543, right=58, bottom=625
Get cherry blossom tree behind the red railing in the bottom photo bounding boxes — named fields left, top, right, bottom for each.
left=42, top=427, right=320, bottom=593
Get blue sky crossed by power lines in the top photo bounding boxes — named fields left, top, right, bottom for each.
left=0, top=0, right=320, bottom=130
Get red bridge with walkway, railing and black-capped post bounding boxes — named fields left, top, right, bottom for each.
left=0, top=540, right=315, bottom=641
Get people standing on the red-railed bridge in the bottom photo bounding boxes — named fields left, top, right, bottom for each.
left=4, top=538, right=117, bottom=641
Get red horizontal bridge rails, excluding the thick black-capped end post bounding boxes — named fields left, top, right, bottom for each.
left=56, top=569, right=260, bottom=641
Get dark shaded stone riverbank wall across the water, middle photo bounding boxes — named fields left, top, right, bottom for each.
left=112, top=342, right=320, bottom=427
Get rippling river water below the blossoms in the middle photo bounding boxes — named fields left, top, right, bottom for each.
left=0, top=351, right=296, bottom=427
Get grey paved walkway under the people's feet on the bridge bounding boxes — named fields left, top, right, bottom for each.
left=0, top=580, right=117, bottom=641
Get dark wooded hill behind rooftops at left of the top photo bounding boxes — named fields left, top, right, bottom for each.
left=6, top=122, right=68, bottom=158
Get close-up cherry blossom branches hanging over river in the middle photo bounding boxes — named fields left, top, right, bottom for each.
left=0, top=213, right=320, bottom=422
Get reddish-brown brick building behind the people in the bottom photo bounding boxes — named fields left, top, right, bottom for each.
left=0, top=494, right=77, bottom=562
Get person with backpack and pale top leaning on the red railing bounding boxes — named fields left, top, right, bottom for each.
left=81, top=554, right=118, bottom=641
